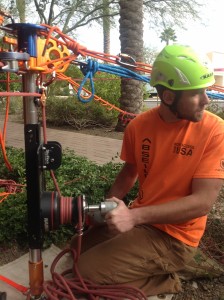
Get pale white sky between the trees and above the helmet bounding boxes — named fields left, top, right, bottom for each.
left=77, top=0, right=224, bottom=55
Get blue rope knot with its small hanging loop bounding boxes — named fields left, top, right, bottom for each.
left=77, top=59, right=99, bottom=103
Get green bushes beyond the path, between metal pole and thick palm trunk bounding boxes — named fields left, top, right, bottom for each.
left=46, top=66, right=120, bottom=130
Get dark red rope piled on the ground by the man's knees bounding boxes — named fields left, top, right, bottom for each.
left=43, top=249, right=147, bottom=300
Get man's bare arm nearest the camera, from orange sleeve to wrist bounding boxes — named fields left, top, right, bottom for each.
left=131, top=178, right=223, bottom=224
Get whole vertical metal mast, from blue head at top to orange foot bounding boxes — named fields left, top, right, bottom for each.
left=11, top=23, right=48, bottom=299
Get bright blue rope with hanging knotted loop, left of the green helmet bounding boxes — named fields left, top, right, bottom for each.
left=77, top=59, right=150, bottom=103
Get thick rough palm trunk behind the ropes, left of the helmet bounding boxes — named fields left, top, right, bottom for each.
left=115, top=0, right=143, bottom=131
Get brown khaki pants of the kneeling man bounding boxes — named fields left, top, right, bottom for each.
left=71, top=225, right=196, bottom=296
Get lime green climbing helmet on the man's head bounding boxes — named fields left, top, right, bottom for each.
left=150, top=45, right=215, bottom=90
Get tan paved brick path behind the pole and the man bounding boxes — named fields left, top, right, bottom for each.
left=0, top=119, right=122, bottom=165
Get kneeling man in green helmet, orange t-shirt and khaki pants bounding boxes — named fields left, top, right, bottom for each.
left=72, top=45, right=224, bottom=295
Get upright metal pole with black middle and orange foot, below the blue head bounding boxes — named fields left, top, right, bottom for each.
left=23, top=72, right=44, bottom=299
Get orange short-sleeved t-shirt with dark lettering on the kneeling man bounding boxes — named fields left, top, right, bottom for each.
left=121, top=108, right=224, bottom=247
